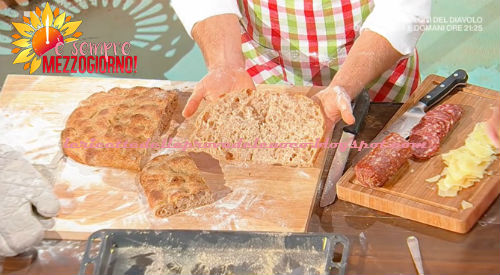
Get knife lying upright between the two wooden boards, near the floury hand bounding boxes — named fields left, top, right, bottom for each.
left=319, top=90, right=370, bottom=207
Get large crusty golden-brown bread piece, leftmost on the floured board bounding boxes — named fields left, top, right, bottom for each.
left=61, top=87, right=177, bottom=171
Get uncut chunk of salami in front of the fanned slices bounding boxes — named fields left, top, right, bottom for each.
left=354, top=133, right=411, bottom=187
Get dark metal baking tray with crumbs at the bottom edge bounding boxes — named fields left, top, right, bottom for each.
left=79, top=230, right=349, bottom=275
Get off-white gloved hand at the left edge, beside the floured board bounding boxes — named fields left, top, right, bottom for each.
left=0, top=144, right=59, bottom=256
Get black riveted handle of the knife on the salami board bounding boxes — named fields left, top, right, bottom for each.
left=420, top=70, right=469, bottom=110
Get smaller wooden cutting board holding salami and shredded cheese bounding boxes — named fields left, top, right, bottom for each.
left=337, top=75, right=500, bottom=233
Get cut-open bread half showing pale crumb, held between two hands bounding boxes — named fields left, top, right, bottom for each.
left=190, top=90, right=325, bottom=167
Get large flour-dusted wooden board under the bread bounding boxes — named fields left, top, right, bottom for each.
left=0, top=75, right=331, bottom=242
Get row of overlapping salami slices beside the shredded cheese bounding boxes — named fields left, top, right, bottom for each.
left=409, top=104, right=462, bottom=160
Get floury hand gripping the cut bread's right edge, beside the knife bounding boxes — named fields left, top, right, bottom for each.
left=314, top=86, right=354, bottom=125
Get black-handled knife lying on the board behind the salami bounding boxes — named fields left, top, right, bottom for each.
left=371, top=70, right=469, bottom=143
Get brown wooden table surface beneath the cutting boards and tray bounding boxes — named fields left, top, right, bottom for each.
left=2, top=104, right=500, bottom=275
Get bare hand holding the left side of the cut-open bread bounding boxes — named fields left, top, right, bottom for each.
left=182, top=67, right=255, bottom=118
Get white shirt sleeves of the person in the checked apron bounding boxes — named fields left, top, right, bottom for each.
left=171, top=0, right=431, bottom=55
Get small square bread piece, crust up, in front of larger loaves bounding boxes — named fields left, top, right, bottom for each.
left=139, top=153, right=213, bottom=217
